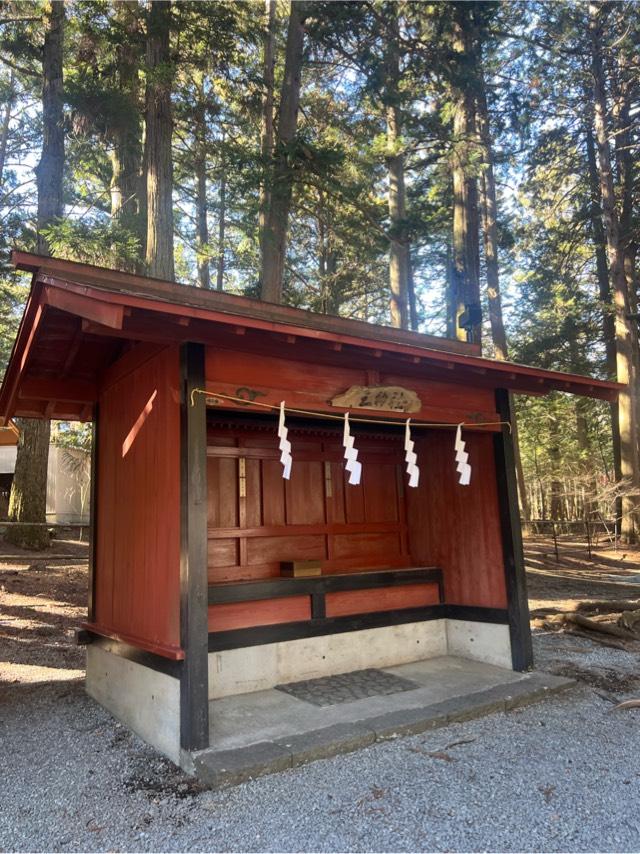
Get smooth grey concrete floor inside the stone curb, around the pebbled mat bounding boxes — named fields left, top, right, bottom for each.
left=209, top=656, right=527, bottom=750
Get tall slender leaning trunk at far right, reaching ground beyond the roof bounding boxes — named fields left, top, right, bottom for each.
left=589, top=2, right=640, bottom=543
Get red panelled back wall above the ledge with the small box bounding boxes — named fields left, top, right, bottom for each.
left=207, top=428, right=411, bottom=583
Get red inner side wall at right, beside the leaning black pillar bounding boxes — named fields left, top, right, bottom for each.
left=407, top=430, right=507, bottom=608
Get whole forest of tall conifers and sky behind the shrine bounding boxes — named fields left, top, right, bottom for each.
left=0, top=0, right=640, bottom=544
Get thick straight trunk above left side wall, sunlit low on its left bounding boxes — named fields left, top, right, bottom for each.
left=145, top=0, right=175, bottom=280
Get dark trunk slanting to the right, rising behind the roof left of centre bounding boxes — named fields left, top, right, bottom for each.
left=260, top=0, right=307, bottom=302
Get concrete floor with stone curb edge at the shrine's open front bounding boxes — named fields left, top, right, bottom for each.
left=192, top=656, right=574, bottom=788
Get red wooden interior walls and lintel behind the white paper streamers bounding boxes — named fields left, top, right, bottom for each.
left=206, top=344, right=506, bottom=631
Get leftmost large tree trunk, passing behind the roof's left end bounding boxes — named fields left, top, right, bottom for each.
left=5, top=0, right=64, bottom=549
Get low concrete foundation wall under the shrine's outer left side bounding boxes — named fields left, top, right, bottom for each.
left=86, top=644, right=182, bottom=765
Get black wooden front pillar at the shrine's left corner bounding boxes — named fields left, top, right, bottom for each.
left=180, top=344, right=209, bottom=750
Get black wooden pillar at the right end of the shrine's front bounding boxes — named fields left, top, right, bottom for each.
left=494, top=388, right=533, bottom=670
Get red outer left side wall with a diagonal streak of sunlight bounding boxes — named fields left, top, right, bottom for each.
left=94, top=345, right=180, bottom=657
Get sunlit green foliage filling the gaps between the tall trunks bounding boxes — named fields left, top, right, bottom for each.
left=0, top=0, right=640, bottom=520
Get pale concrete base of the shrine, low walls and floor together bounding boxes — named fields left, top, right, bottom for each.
left=86, top=620, right=516, bottom=773
